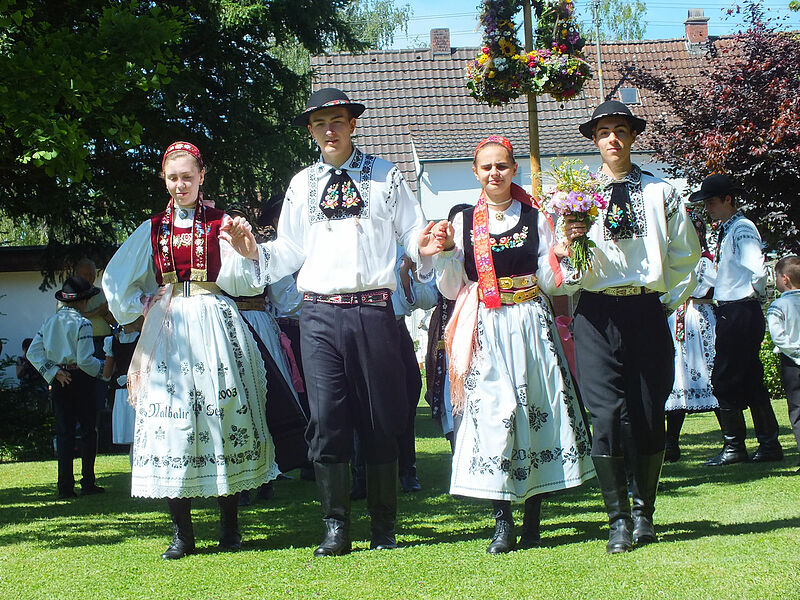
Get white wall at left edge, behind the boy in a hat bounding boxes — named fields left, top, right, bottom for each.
left=0, top=271, right=58, bottom=383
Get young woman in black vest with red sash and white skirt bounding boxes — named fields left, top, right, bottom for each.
left=435, top=136, right=594, bottom=554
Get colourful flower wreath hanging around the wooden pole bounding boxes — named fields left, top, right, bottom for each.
left=467, top=0, right=591, bottom=106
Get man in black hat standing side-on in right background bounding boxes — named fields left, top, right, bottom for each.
left=689, top=174, right=783, bottom=466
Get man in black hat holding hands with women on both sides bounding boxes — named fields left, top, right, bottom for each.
left=223, top=88, right=442, bottom=556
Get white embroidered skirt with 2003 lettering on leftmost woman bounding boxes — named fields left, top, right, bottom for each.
left=131, top=294, right=278, bottom=498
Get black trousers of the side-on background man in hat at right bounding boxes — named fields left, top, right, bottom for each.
left=711, top=299, right=769, bottom=410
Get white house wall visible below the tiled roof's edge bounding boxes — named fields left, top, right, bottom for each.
left=417, top=153, right=688, bottom=220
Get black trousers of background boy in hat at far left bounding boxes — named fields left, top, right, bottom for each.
left=52, top=369, right=97, bottom=491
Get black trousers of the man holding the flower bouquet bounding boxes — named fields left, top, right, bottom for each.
left=573, top=292, right=675, bottom=456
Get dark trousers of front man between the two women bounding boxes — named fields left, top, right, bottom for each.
left=300, top=301, right=408, bottom=464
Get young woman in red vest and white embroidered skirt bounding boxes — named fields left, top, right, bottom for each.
left=103, top=142, right=277, bottom=559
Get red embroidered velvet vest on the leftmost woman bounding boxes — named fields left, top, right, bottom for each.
left=150, top=208, right=225, bottom=285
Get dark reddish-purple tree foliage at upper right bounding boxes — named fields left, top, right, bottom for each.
left=625, top=2, right=800, bottom=251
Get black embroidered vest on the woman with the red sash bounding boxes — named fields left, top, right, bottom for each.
left=462, top=204, right=539, bottom=281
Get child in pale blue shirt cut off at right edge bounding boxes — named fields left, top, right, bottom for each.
left=767, top=256, right=800, bottom=474
